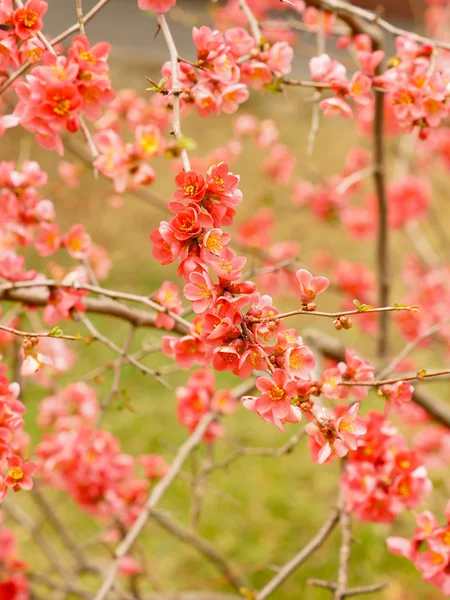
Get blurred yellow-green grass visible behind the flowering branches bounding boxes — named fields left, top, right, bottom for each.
left=0, top=57, right=443, bottom=600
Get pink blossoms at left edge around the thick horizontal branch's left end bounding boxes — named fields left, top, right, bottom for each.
left=0, top=161, right=111, bottom=342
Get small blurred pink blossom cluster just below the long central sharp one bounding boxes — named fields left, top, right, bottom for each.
left=176, top=369, right=237, bottom=442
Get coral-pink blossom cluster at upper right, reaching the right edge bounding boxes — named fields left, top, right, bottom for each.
left=310, top=34, right=448, bottom=136
